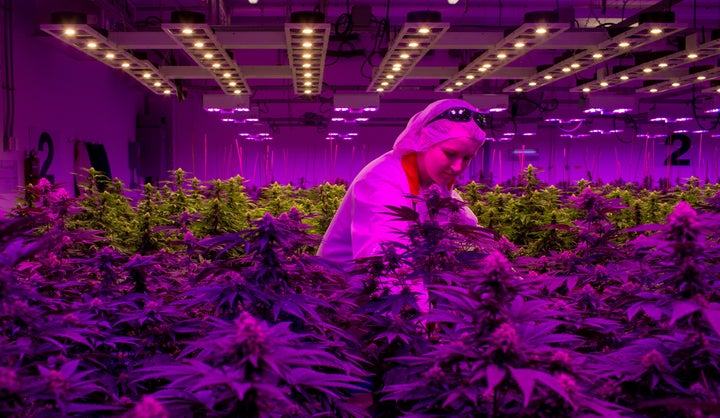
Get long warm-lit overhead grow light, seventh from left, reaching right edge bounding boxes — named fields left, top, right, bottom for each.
left=570, top=30, right=720, bottom=93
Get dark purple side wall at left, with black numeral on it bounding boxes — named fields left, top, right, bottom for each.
left=0, top=1, right=145, bottom=210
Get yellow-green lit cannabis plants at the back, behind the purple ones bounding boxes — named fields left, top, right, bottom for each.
left=12, top=166, right=720, bottom=256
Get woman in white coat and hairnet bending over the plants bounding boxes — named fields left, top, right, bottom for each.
left=318, top=99, right=485, bottom=263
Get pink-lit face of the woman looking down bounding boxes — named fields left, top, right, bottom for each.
left=418, top=137, right=482, bottom=187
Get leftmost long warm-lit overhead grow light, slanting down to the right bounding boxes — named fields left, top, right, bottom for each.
left=40, top=23, right=177, bottom=96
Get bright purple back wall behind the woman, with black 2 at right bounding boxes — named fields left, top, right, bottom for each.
left=174, top=92, right=720, bottom=189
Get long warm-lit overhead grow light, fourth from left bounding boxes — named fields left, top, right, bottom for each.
left=366, top=22, right=450, bottom=93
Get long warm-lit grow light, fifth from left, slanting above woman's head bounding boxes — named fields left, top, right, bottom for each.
left=435, top=15, right=569, bottom=93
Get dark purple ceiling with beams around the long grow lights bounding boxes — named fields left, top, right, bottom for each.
left=38, top=0, right=720, bottom=129
